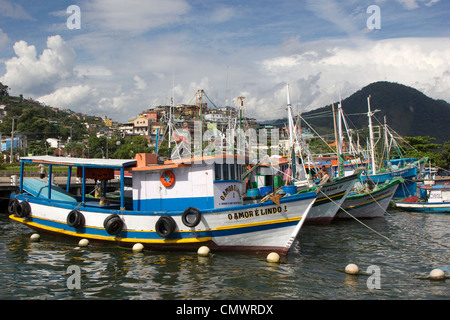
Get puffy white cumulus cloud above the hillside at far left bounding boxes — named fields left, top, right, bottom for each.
left=0, top=35, right=75, bottom=94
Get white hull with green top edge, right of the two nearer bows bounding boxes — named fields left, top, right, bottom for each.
left=335, top=178, right=403, bottom=220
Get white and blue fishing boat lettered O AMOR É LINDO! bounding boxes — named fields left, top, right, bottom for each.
left=8, top=154, right=316, bottom=255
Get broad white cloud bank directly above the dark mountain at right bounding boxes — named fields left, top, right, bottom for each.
left=253, top=38, right=450, bottom=117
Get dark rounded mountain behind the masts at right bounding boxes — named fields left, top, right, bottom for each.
left=302, top=81, right=450, bottom=143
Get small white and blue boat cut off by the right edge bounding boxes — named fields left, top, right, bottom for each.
left=394, top=185, right=450, bottom=213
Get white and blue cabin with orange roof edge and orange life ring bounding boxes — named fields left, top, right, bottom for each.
left=131, top=154, right=251, bottom=211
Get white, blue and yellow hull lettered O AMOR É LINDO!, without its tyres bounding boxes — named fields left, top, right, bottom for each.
left=10, top=192, right=316, bottom=255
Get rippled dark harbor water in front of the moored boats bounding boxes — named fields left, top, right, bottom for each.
left=0, top=211, right=450, bottom=301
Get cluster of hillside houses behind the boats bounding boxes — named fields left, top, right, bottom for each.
left=0, top=90, right=316, bottom=160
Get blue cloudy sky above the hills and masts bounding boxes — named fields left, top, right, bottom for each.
left=0, top=0, right=450, bottom=123
